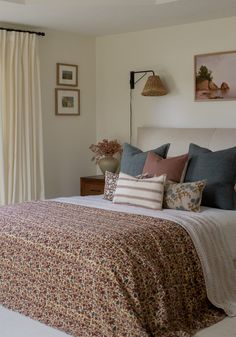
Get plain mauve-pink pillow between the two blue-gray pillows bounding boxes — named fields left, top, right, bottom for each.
left=143, top=151, right=188, bottom=182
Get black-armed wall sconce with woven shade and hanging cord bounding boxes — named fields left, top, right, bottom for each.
left=130, top=70, right=167, bottom=144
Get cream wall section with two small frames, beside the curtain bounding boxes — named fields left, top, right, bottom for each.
left=40, top=30, right=96, bottom=197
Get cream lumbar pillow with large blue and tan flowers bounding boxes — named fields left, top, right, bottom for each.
left=164, top=180, right=206, bottom=212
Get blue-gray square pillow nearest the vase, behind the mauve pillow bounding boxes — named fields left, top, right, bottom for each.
left=120, top=143, right=170, bottom=176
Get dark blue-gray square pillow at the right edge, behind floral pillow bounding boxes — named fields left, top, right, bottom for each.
left=185, top=144, right=236, bottom=209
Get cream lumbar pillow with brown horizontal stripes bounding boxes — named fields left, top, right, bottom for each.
left=113, top=172, right=166, bottom=210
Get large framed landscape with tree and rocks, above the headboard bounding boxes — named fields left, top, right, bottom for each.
left=194, top=51, right=236, bottom=101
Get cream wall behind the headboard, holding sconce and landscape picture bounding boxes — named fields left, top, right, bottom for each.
left=96, top=17, right=236, bottom=143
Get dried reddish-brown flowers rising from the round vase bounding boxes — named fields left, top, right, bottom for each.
left=89, top=139, right=122, bottom=164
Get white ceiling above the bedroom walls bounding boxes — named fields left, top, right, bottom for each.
left=0, top=0, right=236, bottom=36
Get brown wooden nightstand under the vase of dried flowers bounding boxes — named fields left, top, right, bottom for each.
left=80, top=175, right=105, bottom=196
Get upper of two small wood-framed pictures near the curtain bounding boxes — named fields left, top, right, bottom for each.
left=57, top=63, right=78, bottom=87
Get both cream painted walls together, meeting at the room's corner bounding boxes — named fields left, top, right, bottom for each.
left=2, top=17, right=236, bottom=197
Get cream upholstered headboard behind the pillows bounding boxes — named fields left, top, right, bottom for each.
left=137, top=127, right=236, bottom=157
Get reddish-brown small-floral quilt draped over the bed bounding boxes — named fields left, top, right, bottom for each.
left=0, top=201, right=224, bottom=337
